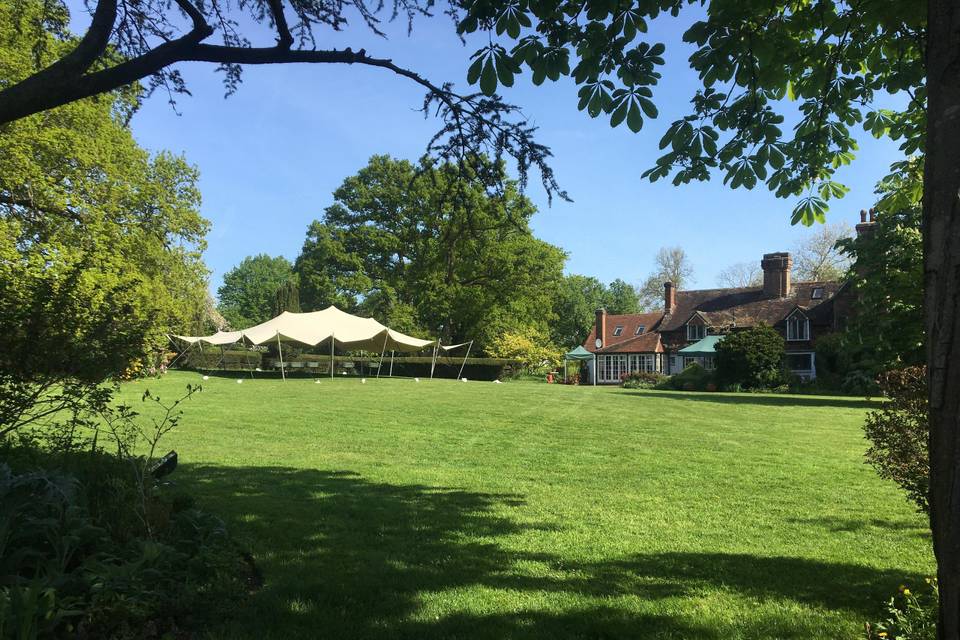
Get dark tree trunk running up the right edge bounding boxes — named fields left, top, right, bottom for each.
left=923, top=0, right=960, bottom=640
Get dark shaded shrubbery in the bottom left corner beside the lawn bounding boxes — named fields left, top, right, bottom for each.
left=0, top=454, right=251, bottom=638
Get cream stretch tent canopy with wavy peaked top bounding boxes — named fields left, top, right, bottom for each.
left=175, top=306, right=434, bottom=352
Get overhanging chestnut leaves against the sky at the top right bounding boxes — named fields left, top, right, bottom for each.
left=459, top=0, right=926, bottom=225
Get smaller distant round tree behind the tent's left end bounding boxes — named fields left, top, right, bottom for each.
left=217, top=253, right=294, bottom=329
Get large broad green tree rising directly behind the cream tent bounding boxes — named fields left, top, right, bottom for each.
left=296, top=156, right=565, bottom=347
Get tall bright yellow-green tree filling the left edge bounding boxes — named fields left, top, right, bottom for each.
left=0, top=2, right=208, bottom=435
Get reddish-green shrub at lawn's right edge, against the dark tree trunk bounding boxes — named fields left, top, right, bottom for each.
left=864, top=367, right=930, bottom=513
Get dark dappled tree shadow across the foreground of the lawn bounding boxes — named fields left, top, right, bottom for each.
left=184, top=465, right=914, bottom=639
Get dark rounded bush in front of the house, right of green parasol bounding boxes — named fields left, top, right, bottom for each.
left=716, top=324, right=785, bottom=389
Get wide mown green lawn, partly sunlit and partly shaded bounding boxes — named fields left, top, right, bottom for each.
left=116, top=372, right=933, bottom=640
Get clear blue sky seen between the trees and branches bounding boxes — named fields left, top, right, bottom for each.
left=74, top=1, right=901, bottom=292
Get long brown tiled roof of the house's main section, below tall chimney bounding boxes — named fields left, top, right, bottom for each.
left=660, top=282, right=842, bottom=331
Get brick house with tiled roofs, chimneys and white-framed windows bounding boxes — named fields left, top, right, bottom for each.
left=583, top=212, right=874, bottom=384
